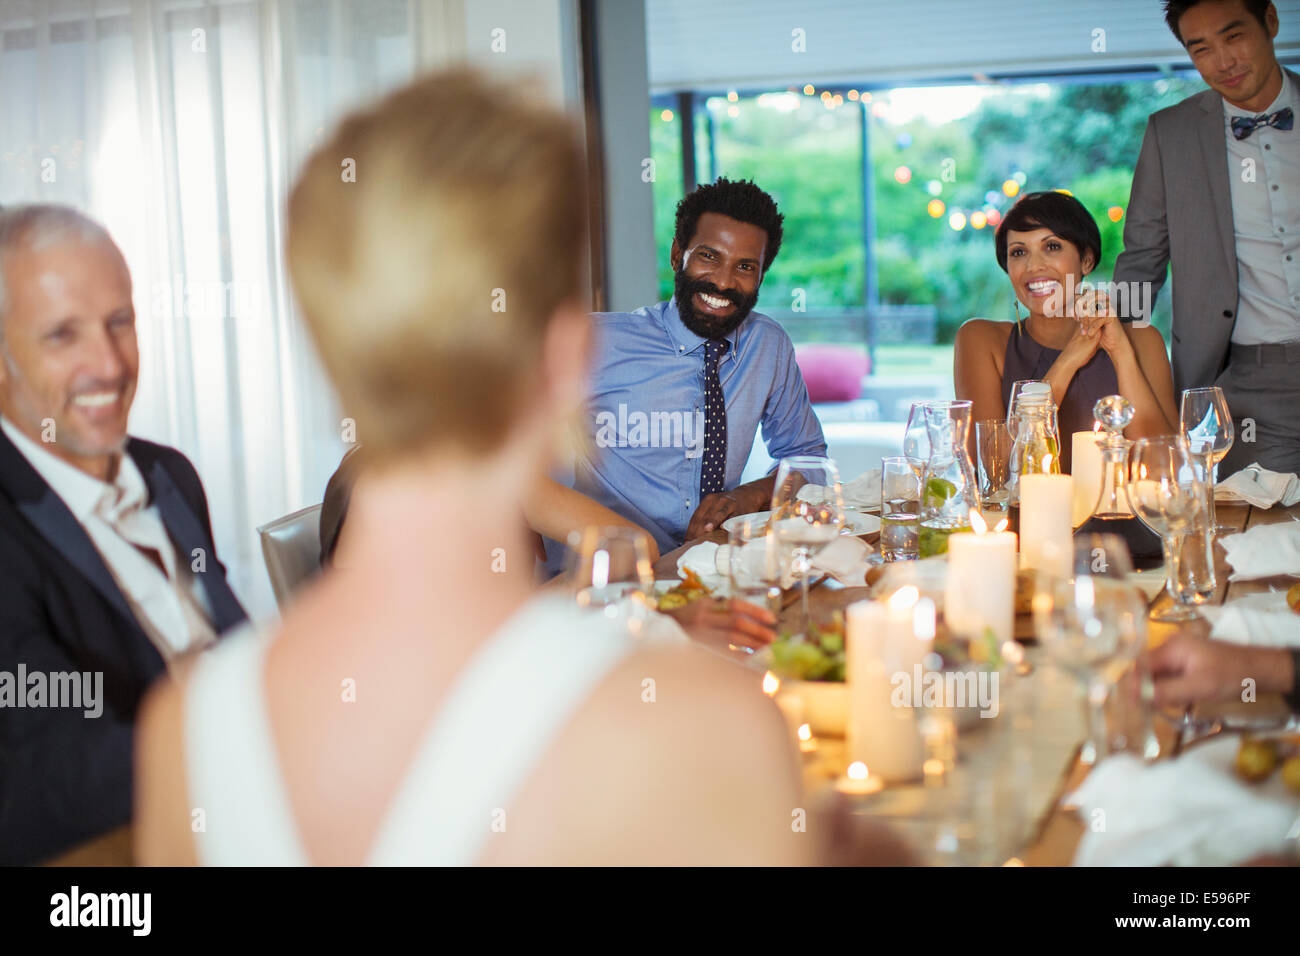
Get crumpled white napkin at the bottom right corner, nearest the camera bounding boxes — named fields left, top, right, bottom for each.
left=1067, top=736, right=1300, bottom=866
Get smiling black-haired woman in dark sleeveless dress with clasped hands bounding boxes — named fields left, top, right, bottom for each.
left=953, top=191, right=1178, bottom=472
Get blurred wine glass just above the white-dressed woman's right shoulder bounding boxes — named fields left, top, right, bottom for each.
left=568, top=525, right=655, bottom=635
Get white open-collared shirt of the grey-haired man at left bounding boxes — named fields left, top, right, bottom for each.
left=0, top=418, right=216, bottom=663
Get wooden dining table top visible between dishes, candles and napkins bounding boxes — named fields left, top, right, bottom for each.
left=654, top=501, right=1300, bottom=866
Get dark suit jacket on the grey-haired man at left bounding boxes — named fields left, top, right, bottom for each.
left=0, top=432, right=246, bottom=864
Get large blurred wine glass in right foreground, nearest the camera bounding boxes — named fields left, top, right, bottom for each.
left=1032, top=535, right=1147, bottom=765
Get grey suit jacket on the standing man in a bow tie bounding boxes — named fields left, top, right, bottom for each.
left=1114, top=70, right=1300, bottom=392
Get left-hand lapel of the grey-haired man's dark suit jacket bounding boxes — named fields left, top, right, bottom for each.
left=0, top=432, right=139, bottom=629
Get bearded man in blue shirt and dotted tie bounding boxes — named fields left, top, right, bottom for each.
left=575, top=178, right=826, bottom=551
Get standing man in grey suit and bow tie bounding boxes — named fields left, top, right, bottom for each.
left=1114, top=0, right=1300, bottom=476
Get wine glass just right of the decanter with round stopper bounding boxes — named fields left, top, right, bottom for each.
left=1125, top=436, right=1216, bottom=620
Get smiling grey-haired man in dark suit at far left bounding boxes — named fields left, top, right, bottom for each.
left=0, top=206, right=244, bottom=864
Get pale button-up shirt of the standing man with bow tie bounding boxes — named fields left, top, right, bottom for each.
left=1223, top=70, right=1300, bottom=345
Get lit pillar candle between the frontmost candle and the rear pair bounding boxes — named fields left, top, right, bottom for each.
left=944, top=505, right=1023, bottom=646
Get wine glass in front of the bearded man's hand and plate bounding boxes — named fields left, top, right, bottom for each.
left=771, top=455, right=845, bottom=635
